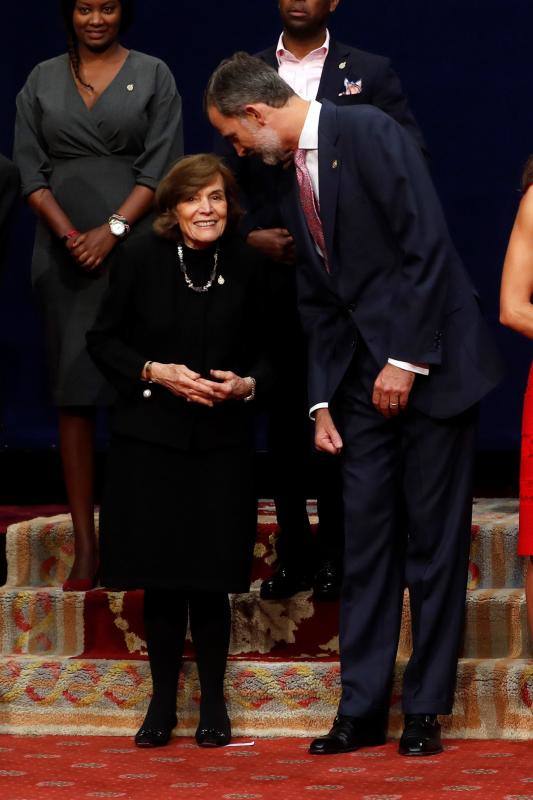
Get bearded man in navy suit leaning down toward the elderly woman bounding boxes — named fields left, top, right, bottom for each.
left=206, top=54, right=501, bottom=755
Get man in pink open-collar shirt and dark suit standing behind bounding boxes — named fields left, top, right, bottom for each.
left=226, top=0, right=425, bottom=599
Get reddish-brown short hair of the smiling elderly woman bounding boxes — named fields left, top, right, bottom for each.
left=154, top=153, right=242, bottom=239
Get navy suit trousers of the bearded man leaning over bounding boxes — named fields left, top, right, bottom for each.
left=332, top=340, right=478, bottom=717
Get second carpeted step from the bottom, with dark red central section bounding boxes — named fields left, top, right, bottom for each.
left=0, top=588, right=529, bottom=661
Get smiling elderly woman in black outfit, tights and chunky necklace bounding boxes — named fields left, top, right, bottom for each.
left=87, top=155, right=272, bottom=747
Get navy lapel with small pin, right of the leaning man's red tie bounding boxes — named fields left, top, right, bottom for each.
left=318, top=101, right=342, bottom=272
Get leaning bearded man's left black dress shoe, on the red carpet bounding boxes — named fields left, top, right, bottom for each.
left=309, top=714, right=387, bottom=756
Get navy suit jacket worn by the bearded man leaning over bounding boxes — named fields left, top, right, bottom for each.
left=282, top=102, right=501, bottom=418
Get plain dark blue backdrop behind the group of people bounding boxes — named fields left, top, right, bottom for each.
left=0, top=0, right=533, bottom=451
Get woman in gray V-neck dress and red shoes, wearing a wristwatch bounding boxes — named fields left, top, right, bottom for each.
left=15, top=0, right=183, bottom=590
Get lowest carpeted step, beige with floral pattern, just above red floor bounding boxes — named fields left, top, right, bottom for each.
left=0, top=656, right=533, bottom=739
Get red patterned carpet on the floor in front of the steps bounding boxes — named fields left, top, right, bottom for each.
left=0, top=736, right=533, bottom=800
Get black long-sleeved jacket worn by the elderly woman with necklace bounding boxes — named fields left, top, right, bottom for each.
left=87, top=233, right=273, bottom=450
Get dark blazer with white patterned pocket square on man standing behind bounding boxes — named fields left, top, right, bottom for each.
left=215, top=38, right=427, bottom=237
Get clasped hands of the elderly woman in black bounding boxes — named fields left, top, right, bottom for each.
left=151, top=362, right=252, bottom=407
